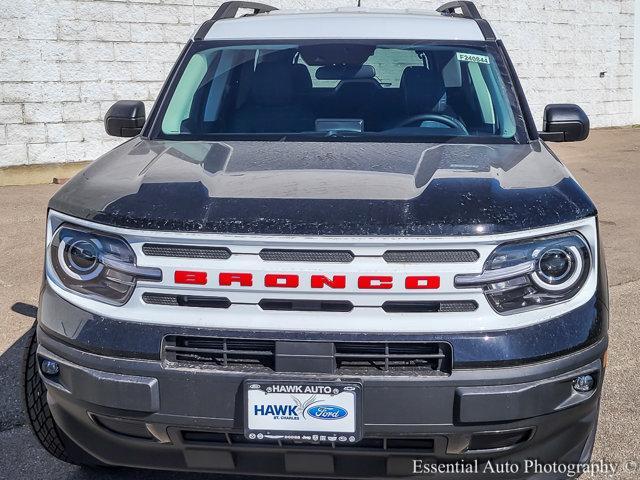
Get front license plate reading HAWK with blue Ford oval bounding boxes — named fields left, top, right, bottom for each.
left=245, top=380, right=362, bottom=443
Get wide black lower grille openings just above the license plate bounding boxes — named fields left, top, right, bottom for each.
left=164, top=335, right=452, bottom=376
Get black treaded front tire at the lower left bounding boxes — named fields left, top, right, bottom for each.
left=22, top=324, right=103, bottom=467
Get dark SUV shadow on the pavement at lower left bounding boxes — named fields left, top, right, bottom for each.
left=0, top=302, right=270, bottom=480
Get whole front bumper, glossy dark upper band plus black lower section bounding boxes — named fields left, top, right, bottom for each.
left=33, top=278, right=608, bottom=478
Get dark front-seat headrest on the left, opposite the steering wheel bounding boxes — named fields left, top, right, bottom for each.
left=251, top=62, right=293, bottom=106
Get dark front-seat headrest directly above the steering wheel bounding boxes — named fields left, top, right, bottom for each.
left=400, top=67, right=446, bottom=115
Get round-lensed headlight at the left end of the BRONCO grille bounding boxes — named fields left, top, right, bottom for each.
left=49, top=224, right=162, bottom=305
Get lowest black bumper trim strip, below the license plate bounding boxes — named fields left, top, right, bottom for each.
left=46, top=396, right=598, bottom=479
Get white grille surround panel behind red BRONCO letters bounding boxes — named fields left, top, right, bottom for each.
left=46, top=211, right=598, bottom=333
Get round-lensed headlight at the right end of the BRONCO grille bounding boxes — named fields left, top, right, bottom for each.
left=455, top=232, right=591, bottom=313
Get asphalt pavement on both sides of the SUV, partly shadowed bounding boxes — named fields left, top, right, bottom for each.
left=0, top=129, right=640, bottom=480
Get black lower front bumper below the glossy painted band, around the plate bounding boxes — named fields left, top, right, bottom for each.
left=38, top=328, right=606, bottom=478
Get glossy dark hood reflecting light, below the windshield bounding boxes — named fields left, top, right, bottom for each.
left=49, top=138, right=596, bottom=236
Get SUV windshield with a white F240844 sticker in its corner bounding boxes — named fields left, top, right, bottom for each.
left=159, top=41, right=523, bottom=143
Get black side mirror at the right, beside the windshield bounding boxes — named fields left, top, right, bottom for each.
left=540, top=103, right=589, bottom=142
